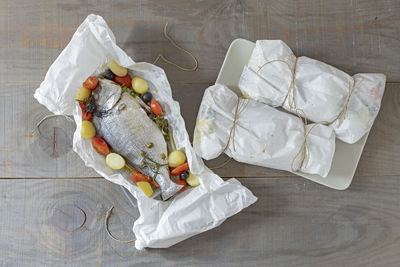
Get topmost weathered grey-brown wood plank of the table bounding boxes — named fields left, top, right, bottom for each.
left=0, top=0, right=400, bottom=83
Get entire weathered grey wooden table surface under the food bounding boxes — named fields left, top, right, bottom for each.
left=0, top=0, right=400, bottom=266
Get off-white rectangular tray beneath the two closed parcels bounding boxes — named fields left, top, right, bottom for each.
left=216, top=39, right=368, bottom=190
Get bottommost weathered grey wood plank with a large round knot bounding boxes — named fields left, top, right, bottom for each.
left=0, top=176, right=400, bottom=266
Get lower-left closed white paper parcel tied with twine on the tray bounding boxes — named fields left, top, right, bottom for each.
left=193, top=84, right=335, bottom=177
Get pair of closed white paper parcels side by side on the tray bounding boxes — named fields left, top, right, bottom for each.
left=193, top=40, right=386, bottom=177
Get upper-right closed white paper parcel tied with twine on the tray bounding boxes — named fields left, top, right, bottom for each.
left=239, top=40, right=386, bottom=144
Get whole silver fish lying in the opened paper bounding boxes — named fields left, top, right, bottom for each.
left=93, top=79, right=182, bottom=200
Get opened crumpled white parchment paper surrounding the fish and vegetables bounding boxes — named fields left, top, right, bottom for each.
left=35, top=15, right=256, bottom=249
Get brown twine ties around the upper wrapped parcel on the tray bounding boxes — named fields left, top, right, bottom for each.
left=257, top=57, right=355, bottom=126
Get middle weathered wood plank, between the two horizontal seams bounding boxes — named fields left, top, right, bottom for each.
left=0, top=83, right=400, bottom=178
